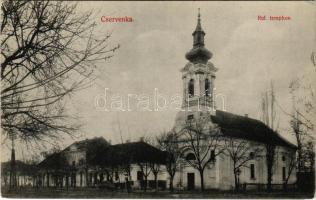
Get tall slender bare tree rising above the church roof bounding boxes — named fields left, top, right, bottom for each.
left=261, top=81, right=277, bottom=191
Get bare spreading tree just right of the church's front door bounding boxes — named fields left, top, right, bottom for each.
left=180, top=118, right=224, bottom=191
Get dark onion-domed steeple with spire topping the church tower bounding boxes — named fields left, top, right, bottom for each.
left=185, top=9, right=212, bottom=64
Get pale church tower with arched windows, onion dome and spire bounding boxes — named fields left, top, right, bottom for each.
left=176, top=9, right=217, bottom=131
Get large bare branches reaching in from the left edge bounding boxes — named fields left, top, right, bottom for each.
left=0, top=0, right=118, bottom=188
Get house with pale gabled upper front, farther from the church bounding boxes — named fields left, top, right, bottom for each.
left=37, top=137, right=110, bottom=187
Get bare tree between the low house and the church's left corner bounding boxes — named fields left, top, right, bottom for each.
left=157, top=131, right=181, bottom=192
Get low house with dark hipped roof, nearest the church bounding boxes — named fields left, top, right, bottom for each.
left=98, top=141, right=167, bottom=189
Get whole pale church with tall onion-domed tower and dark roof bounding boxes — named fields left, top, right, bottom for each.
left=173, top=10, right=296, bottom=190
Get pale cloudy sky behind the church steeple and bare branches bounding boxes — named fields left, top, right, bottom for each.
left=2, top=1, right=316, bottom=162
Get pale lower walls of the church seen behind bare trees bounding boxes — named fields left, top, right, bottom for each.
left=174, top=138, right=296, bottom=190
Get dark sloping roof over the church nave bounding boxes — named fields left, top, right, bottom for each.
left=211, top=110, right=297, bottom=148
